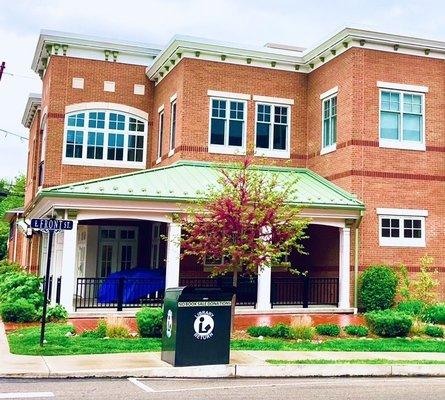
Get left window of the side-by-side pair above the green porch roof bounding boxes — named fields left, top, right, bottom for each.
left=209, top=98, right=246, bottom=154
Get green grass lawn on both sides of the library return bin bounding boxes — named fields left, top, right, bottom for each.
left=8, top=324, right=445, bottom=355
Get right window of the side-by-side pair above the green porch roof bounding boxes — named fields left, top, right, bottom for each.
left=255, top=103, right=290, bottom=158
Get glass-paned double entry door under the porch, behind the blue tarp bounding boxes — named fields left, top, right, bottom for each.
left=98, top=226, right=138, bottom=277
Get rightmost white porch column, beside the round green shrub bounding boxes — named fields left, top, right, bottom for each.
left=338, top=227, right=351, bottom=308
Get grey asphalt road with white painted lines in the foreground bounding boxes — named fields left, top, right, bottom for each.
left=0, top=378, right=445, bottom=400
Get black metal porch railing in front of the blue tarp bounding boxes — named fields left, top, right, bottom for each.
left=75, top=278, right=164, bottom=311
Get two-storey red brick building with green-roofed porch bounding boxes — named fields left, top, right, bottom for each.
left=4, top=28, right=445, bottom=311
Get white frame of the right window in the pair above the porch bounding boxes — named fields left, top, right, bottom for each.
left=254, top=101, right=292, bottom=158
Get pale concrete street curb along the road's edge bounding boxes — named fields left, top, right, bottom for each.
left=0, top=364, right=445, bottom=379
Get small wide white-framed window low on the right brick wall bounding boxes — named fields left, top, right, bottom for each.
left=377, top=209, right=427, bottom=247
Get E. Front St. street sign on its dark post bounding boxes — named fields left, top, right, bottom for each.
left=31, top=218, right=73, bottom=346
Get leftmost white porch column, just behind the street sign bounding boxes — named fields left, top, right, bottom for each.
left=59, top=219, right=77, bottom=312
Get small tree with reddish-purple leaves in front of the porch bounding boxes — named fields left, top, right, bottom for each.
left=176, top=158, right=309, bottom=287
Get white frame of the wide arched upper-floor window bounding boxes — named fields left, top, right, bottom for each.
left=62, top=108, right=148, bottom=169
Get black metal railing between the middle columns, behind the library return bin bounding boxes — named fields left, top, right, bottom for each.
left=179, top=275, right=257, bottom=306
